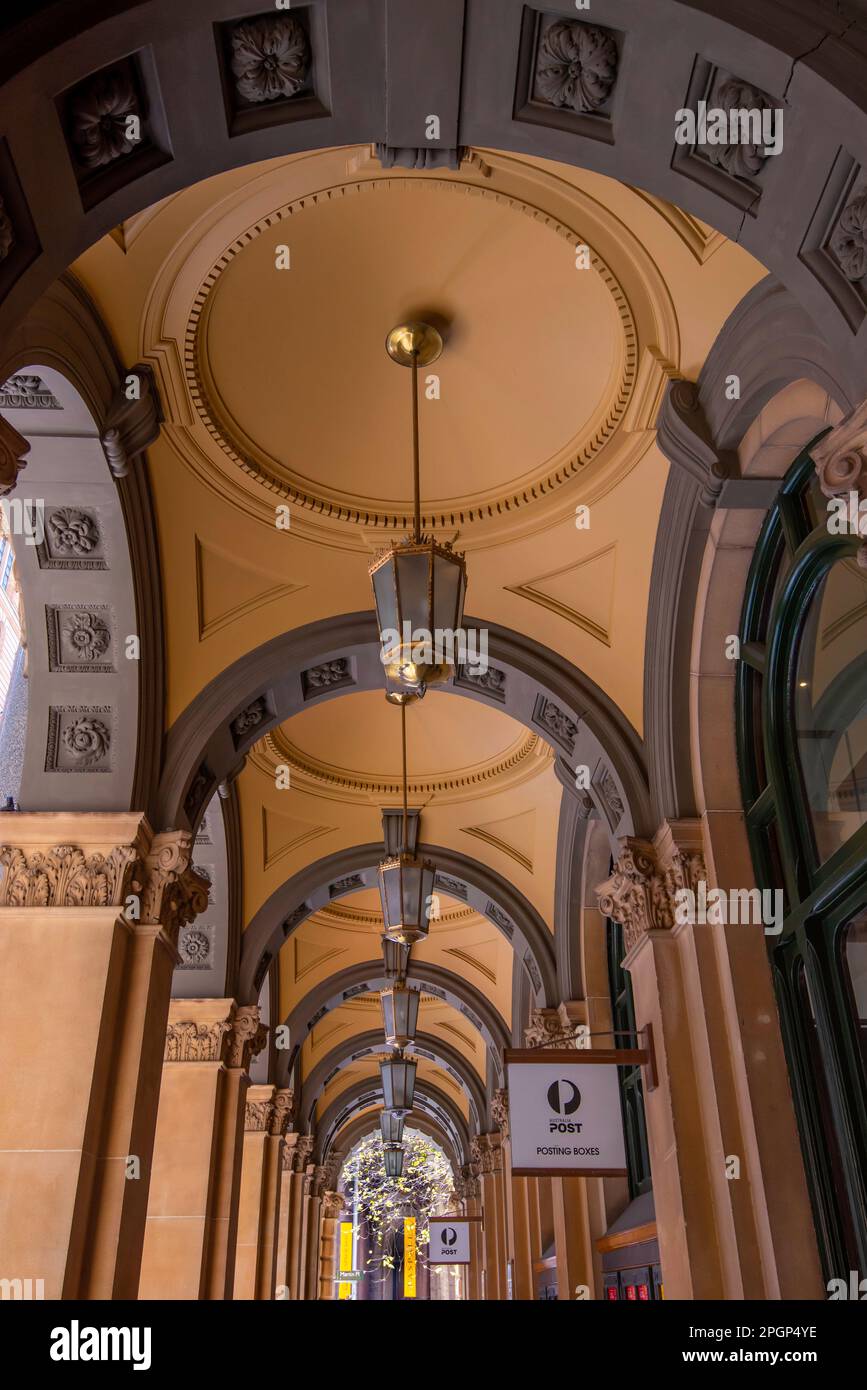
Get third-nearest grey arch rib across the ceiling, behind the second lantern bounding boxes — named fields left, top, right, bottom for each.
left=240, top=844, right=557, bottom=1006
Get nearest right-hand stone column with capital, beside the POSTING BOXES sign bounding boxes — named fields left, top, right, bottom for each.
left=599, top=821, right=744, bottom=1298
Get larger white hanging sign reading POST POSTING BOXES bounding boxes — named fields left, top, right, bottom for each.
left=507, top=1052, right=627, bottom=1175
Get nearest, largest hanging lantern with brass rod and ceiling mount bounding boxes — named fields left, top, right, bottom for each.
left=370, top=322, right=467, bottom=694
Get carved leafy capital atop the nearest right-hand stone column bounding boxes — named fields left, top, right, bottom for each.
left=596, top=821, right=707, bottom=951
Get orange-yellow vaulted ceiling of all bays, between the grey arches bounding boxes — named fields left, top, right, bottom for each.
left=74, top=146, right=763, bottom=1150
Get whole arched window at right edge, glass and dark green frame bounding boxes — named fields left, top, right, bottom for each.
left=738, top=441, right=867, bottom=1279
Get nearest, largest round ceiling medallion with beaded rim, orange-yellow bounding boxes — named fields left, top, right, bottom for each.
left=185, top=175, right=636, bottom=530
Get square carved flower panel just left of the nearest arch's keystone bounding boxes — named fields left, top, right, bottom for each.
left=214, top=6, right=331, bottom=135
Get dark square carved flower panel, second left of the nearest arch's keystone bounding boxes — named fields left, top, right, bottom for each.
left=56, top=49, right=171, bottom=209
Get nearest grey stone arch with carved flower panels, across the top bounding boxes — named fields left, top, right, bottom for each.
left=0, top=0, right=867, bottom=389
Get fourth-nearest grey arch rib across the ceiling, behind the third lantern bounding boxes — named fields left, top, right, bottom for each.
left=278, top=959, right=510, bottom=1086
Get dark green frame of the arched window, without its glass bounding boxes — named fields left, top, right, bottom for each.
left=736, top=431, right=867, bottom=1279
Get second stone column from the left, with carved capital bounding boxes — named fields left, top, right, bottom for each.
left=139, top=999, right=265, bottom=1298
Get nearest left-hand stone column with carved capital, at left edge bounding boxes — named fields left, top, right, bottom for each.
left=0, top=813, right=207, bottom=1300
